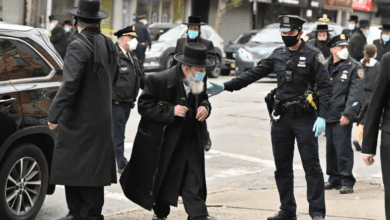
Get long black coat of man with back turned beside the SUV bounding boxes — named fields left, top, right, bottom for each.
left=48, top=28, right=117, bottom=186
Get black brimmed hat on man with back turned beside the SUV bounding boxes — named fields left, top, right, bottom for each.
left=69, top=0, right=110, bottom=20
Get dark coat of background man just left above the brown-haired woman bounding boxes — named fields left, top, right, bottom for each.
left=348, top=29, right=367, bottom=62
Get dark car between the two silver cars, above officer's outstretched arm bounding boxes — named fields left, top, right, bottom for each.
left=221, top=30, right=260, bottom=76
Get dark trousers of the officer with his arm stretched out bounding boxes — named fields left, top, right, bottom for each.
left=271, top=112, right=325, bottom=217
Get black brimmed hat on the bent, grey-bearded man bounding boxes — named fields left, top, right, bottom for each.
left=174, top=42, right=215, bottom=67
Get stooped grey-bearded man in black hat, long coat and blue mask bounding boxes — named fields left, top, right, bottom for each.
left=120, top=43, right=216, bottom=220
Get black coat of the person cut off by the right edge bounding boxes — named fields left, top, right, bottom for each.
left=362, top=53, right=390, bottom=155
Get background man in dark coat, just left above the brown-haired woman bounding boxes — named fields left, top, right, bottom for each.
left=348, top=20, right=370, bottom=62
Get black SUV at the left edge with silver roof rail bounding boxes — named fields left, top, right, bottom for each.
left=0, top=22, right=63, bottom=220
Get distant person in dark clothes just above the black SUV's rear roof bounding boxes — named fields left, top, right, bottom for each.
left=49, top=15, right=68, bottom=59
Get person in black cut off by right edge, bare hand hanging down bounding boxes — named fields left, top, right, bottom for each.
left=362, top=53, right=390, bottom=219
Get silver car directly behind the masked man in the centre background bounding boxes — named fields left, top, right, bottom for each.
left=144, top=25, right=225, bottom=78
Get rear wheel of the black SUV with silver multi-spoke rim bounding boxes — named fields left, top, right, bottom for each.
left=0, top=143, right=49, bottom=219
